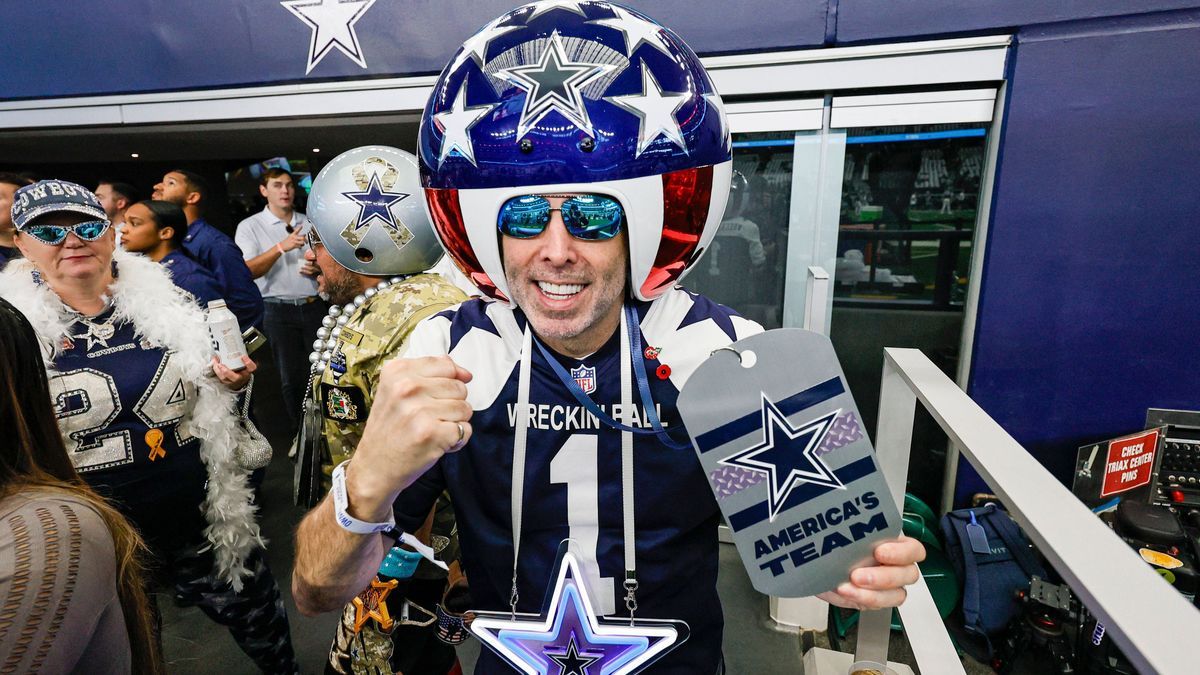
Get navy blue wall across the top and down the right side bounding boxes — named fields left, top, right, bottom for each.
left=0, top=0, right=1200, bottom=495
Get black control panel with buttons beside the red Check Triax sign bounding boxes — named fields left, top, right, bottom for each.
left=1146, top=408, right=1200, bottom=507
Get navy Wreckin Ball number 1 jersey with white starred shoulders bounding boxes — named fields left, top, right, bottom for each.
left=396, top=289, right=762, bottom=674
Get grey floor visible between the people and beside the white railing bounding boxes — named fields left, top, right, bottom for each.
left=158, top=357, right=991, bottom=675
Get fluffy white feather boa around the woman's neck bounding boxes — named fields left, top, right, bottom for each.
left=0, top=247, right=265, bottom=591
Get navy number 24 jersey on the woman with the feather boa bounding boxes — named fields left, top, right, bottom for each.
left=50, top=310, right=206, bottom=548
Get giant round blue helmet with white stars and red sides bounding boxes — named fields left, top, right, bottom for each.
left=419, top=0, right=732, bottom=300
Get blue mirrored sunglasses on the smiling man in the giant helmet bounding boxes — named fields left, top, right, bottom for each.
left=496, top=195, right=625, bottom=241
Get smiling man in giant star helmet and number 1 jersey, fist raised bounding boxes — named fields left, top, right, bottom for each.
left=293, top=0, right=923, bottom=674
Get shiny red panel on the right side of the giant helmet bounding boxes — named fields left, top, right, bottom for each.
left=642, top=166, right=713, bottom=298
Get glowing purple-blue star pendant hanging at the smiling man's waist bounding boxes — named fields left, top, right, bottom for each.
left=470, top=542, right=688, bottom=675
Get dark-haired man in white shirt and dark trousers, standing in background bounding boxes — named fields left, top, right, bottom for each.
left=234, top=168, right=328, bottom=434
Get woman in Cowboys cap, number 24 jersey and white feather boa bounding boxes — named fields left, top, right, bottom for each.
left=0, top=180, right=296, bottom=673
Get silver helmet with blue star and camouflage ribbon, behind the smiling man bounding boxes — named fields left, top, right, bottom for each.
left=307, top=145, right=442, bottom=276
